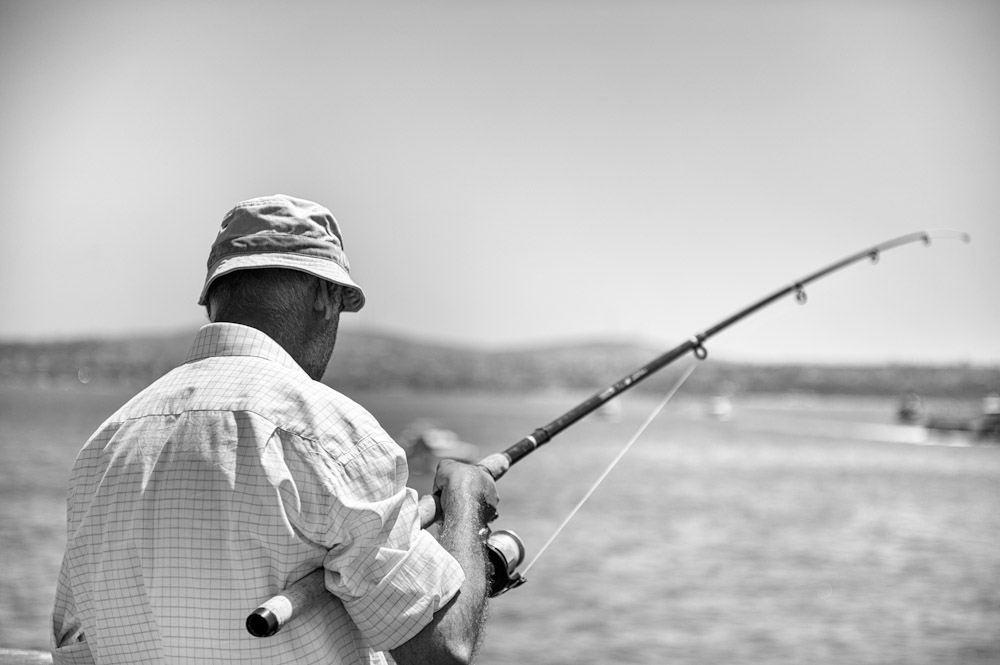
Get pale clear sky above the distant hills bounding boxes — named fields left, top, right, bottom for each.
left=0, top=0, right=1000, bottom=364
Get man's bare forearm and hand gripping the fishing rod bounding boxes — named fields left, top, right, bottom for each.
left=391, top=460, right=498, bottom=665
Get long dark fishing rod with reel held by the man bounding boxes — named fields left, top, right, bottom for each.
left=246, top=229, right=971, bottom=637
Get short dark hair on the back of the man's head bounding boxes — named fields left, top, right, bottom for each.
left=205, top=268, right=318, bottom=327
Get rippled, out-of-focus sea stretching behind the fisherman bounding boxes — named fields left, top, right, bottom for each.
left=0, top=384, right=1000, bottom=665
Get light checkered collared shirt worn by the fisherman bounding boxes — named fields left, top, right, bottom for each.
left=52, top=323, right=464, bottom=664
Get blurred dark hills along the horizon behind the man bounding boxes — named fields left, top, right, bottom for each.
left=0, top=330, right=1000, bottom=399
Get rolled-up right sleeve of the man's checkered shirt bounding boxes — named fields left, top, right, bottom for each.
left=278, top=426, right=465, bottom=651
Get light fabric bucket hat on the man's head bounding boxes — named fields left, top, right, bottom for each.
left=198, top=194, right=365, bottom=312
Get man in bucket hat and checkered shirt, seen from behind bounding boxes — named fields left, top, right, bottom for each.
left=53, top=195, right=498, bottom=664
